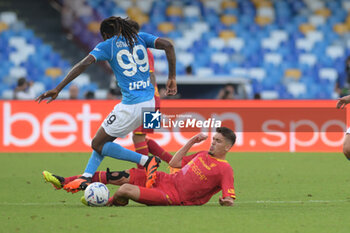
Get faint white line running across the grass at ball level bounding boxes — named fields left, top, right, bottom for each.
left=0, top=200, right=350, bottom=206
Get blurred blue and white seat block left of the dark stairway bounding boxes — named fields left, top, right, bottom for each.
left=0, top=10, right=113, bottom=99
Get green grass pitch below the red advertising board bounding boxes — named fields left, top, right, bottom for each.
left=0, top=153, right=350, bottom=233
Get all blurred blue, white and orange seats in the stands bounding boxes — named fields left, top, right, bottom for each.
left=0, top=0, right=350, bottom=99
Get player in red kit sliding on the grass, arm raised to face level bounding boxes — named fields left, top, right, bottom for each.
left=43, top=127, right=236, bottom=206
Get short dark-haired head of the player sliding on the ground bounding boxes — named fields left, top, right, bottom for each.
left=209, top=127, right=236, bottom=156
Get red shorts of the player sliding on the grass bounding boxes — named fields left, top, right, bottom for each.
left=129, top=168, right=180, bottom=205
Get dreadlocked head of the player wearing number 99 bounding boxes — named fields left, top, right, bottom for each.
left=100, top=16, right=137, bottom=48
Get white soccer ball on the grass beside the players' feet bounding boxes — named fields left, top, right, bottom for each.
left=84, top=182, right=109, bottom=206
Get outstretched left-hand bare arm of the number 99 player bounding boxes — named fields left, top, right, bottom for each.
left=36, top=54, right=95, bottom=103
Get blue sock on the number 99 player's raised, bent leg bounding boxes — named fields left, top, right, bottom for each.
left=102, top=142, right=142, bottom=164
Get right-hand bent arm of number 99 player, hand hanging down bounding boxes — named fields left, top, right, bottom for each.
left=155, top=38, right=177, bottom=95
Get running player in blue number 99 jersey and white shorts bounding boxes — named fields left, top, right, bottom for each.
left=36, top=16, right=177, bottom=193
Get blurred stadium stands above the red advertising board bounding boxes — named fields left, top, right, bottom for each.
left=0, top=0, right=350, bottom=99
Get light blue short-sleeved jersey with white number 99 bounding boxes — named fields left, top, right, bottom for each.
left=90, top=32, right=157, bottom=104
